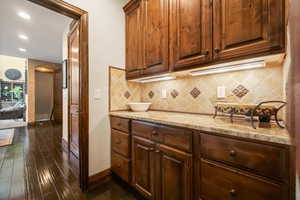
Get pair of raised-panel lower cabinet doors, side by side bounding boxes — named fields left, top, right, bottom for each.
left=132, top=136, right=192, bottom=200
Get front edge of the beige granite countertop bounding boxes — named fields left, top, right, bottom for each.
left=109, top=111, right=292, bottom=145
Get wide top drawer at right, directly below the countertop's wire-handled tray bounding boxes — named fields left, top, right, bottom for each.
left=201, top=134, right=288, bottom=179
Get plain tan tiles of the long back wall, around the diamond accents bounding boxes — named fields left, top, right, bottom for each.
left=141, top=66, right=283, bottom=114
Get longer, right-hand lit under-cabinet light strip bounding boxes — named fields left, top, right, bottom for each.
left=190, top=61, right=266, bottom=76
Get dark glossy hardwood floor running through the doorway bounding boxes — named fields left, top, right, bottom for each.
left=0, top=123, right=140, bottom=200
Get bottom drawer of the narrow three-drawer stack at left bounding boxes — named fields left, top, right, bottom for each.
left=111, top=152, right=130, bottom=183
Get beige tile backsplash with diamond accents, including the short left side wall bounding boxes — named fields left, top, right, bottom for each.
left=111, top=65, right=283, bottom=114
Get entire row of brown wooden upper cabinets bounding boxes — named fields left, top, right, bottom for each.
left=124, top=0, right=287, bottom=79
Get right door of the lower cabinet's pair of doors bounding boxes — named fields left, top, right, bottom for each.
left=155, top=145, right=192, bottom=200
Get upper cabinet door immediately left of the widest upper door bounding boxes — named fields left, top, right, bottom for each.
left=170, top=0, right=212, bottom=70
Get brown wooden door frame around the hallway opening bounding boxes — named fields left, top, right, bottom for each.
left=27, top=0, right=89, bottom=191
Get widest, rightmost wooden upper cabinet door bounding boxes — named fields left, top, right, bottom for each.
left=213, top=0, right=285, bottom=60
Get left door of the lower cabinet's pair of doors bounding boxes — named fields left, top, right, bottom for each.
left=132, top=136, right=155, bottom=199
